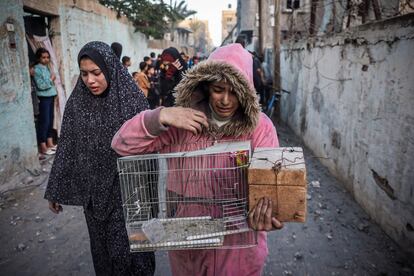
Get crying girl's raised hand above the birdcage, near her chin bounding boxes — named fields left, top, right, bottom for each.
left=159, top=107, right=208, bottom=135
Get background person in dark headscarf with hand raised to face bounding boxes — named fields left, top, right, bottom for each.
left=160, top=47, right=187, bottom=106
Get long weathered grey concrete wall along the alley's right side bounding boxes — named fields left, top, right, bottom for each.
left=281, top=14, right=414, bottom=254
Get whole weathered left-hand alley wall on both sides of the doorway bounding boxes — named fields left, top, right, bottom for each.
left=0, top=0, right=149, bottom=190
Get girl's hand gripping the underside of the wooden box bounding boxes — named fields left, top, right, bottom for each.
left=248, top=198, right=283, bottom=231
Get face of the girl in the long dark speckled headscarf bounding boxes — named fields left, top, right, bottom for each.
left=79, top=58, right=108, bottom=96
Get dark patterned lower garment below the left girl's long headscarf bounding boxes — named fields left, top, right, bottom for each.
left=85, top=203, right=155, bottom=276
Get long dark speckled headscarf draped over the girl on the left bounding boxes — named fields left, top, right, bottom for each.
left=45, top=41, right=148, bottom=219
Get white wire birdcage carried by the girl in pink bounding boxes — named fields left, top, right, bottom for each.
left=118, top=141, right=256, bottom=251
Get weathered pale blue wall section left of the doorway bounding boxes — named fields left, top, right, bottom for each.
left=0, top=0, right=39, bottom=187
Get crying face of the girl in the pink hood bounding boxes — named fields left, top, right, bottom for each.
left=208, top=81, right=240, bottom=118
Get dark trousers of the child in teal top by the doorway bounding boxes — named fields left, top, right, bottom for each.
left=37, top=96, right=55, bottom=143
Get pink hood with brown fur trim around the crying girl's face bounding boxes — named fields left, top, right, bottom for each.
left=175, top=44, right=260, bottom=137
